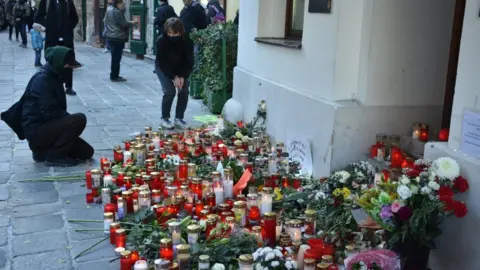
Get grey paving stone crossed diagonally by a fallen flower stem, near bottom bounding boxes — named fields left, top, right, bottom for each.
left=71, top=239, right=116, bottom=262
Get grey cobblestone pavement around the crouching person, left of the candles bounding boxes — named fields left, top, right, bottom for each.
left=0, top=32, right=207, bottom=270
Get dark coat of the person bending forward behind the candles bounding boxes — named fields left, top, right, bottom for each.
left=155, top=33, right=194, bottom=79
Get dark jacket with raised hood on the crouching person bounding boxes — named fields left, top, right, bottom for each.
left=1, top=46, right=71, bottom=140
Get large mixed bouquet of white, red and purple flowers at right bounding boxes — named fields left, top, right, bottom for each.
left=357, top=157, right=468, bottom=248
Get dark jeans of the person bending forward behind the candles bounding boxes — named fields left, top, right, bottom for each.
left=155, top=67, right=188, bottom=119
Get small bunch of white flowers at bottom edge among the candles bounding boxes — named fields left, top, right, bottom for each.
left=252, top=247, right=297, bottom=270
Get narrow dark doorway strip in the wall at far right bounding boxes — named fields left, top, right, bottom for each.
left=442, top=0, right=466, bottom=128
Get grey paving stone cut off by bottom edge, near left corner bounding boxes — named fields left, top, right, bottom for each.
left=12, top=249, right=73, bottom=270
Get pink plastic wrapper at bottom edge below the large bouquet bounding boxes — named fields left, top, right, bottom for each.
left=345, top=249, right=401, bottom=270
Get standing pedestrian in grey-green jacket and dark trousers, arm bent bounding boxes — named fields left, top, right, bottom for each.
left=104, top=0, right=135, bottom=82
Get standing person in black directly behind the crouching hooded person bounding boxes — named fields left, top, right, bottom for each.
left=35, top=0, right=78, bottom=96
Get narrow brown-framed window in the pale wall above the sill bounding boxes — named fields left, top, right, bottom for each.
left=285, top=0, right=305, bottom=39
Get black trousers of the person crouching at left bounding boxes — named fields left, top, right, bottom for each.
left=29, top=113, right=94, bottom=160
